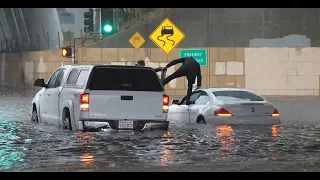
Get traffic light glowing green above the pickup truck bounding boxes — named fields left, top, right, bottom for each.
left=100, top=8, right=114, bottom=35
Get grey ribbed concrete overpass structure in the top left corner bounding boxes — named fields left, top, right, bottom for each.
left=0, top=8, right=63, bottom=52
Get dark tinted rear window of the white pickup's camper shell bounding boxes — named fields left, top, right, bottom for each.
left=89, top=67, right=163, bottom=92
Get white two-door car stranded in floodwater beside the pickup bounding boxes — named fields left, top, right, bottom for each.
left=168, top=88, right=280, bottom=124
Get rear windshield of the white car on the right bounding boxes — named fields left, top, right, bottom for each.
left=212, top=91, right=264, bottom=101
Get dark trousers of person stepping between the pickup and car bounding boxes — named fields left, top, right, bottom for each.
left=163, top=68, right=196, bottom=105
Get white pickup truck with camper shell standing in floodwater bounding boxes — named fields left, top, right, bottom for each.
left=31, top=65, right=169, bottom=131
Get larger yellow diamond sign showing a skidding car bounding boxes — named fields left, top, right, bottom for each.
left=149, top=18, right=185, bottom=54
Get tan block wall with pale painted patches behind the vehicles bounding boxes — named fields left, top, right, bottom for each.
left=0, top=47, right=320, bottom=96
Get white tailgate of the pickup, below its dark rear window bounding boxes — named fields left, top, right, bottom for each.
left=89, top=90, right=163, bottom=120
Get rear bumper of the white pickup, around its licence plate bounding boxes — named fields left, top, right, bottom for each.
left=80, top=119, right=169, bottom=131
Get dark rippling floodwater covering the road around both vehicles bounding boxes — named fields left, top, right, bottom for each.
left=0, top=90, right=320, bottom=172
